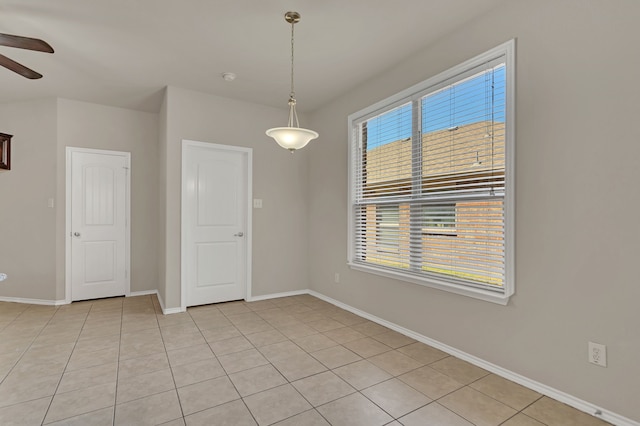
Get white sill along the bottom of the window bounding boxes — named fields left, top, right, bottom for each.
left=348, top=263, right=513, bottom=305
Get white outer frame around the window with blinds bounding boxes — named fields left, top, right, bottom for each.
left=347, top=40, right=516, bottom=305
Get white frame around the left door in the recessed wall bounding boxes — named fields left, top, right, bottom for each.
left=64, top=146, right=131, bottom=303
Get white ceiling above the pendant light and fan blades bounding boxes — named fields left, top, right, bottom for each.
left=0, top=0, right=504, bottom=111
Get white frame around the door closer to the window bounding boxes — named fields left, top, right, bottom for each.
left=180, top=139, right=253, bottom=312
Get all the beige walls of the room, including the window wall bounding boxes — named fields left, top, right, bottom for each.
left=0, top=0, right=640, bottom=420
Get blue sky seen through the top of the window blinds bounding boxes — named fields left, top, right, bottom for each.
left=367, top=66, right=506, bottom=149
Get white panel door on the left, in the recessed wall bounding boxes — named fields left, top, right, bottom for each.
left=67, top=148, right=130, bottom=300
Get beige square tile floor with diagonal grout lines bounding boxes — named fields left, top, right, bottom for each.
left=0, top=295, right=606, bottom=426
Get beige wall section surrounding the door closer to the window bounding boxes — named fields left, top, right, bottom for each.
left=159, top=87, right=310, bottom=308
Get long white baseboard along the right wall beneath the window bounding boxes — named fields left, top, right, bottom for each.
left=306, top=290, right=640, bottom=426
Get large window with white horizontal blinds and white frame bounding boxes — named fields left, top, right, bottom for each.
left=349, top=41, right=515, bottom=304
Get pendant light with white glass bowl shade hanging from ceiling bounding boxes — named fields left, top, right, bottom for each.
left=266, top=12, right=319, bottom=153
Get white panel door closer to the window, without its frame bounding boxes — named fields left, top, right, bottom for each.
left=182, top=141, right=251, bottom=307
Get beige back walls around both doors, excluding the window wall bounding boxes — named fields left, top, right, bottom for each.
left=0, top=88, right=307, bottom=308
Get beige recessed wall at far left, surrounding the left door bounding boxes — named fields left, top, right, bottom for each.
left=0, top=99, right=158, bottom=301
